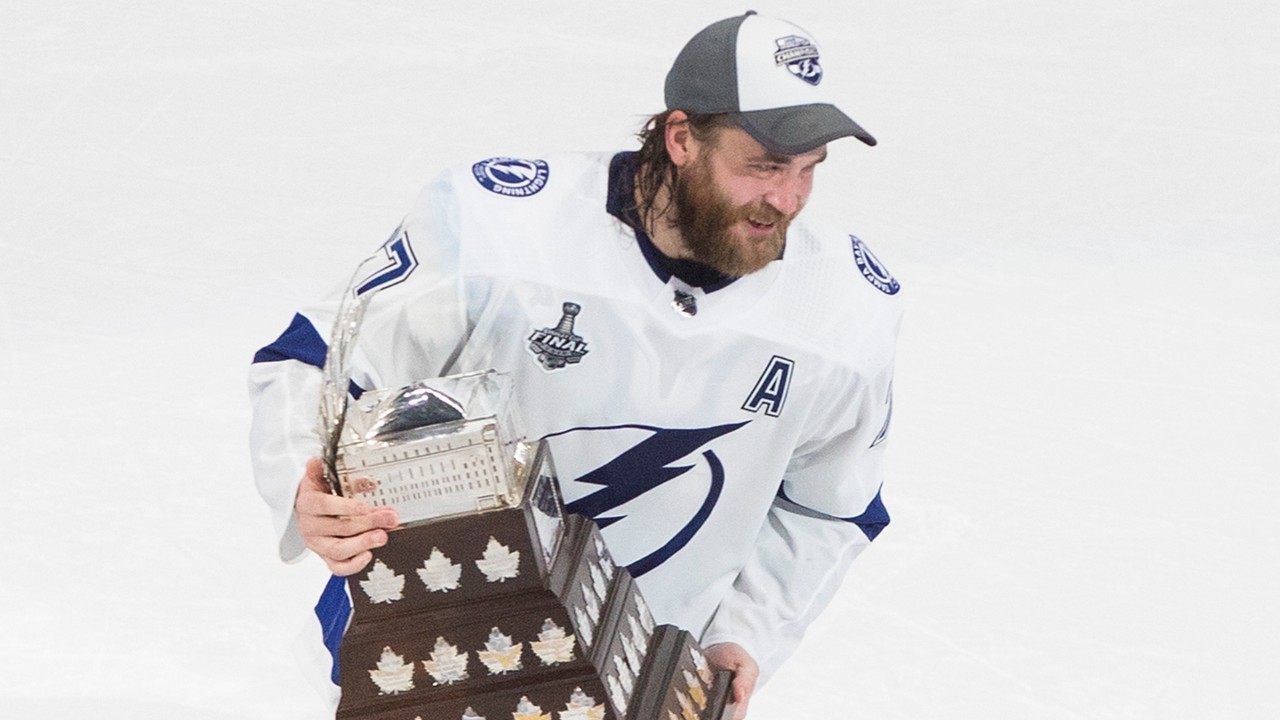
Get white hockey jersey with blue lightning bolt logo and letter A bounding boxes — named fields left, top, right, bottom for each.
left=251, top=154, right=901, bottom=691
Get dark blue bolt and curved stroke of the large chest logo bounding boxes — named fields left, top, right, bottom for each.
left=548, top=420, right=750, bottom=578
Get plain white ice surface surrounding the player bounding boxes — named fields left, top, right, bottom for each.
left=0, top=0, right=1280, bottom=720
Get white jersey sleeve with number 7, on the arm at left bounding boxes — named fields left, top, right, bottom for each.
left=248, top=176, right=467, bottom=561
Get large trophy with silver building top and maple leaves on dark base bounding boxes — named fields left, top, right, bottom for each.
left=332, top=372, right=733, bottom=720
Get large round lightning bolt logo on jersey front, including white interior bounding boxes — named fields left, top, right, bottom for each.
left=548, top=421, right=748, bottom=577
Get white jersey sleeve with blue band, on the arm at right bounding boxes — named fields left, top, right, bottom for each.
left=701, top=317, right=892, bottom=684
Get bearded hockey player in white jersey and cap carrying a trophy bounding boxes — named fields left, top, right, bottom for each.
left=251, top=13, right=901, bottom=716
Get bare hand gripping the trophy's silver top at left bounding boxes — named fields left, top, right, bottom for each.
left=293, top=457, right=399, bottom=575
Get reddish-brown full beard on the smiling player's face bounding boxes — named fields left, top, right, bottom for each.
left=671, top=155, right=799, bottom=278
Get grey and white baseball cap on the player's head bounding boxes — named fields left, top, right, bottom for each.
left=666, top=10, right=876, bottom=155
